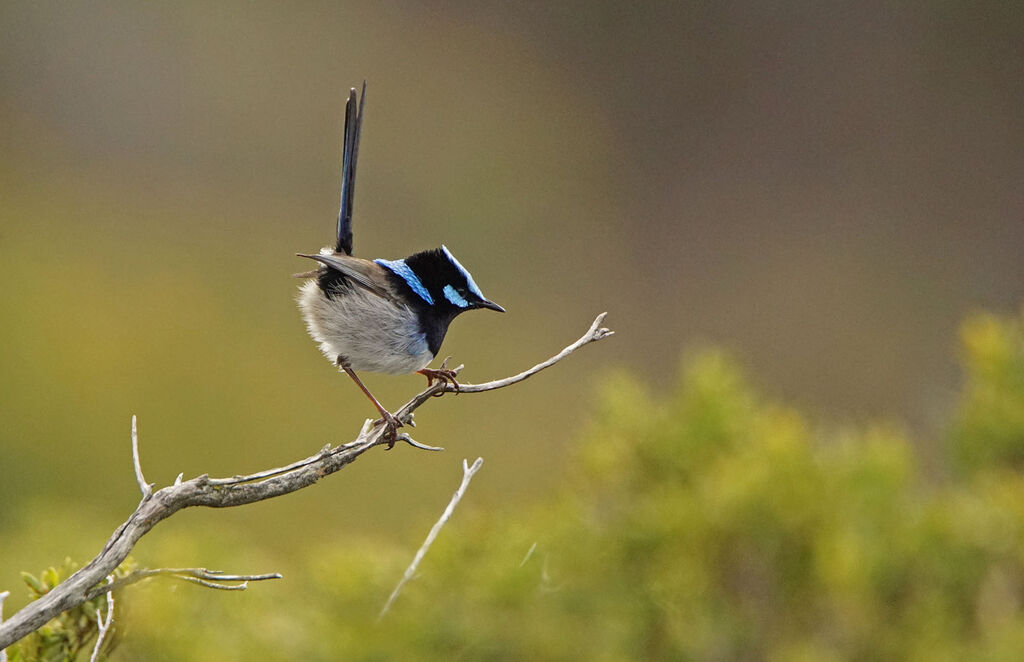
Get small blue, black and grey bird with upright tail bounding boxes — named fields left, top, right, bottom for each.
left=295, top=81, right=505, bottom=445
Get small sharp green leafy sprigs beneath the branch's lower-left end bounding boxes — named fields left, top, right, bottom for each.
left=7, top=558, right=131, bottom=662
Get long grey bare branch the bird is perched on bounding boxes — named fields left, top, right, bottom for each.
left=0, top=313, right=612, bottom=650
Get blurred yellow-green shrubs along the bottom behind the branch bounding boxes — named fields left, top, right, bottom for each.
left=8, top=309, right=1024, bottom=662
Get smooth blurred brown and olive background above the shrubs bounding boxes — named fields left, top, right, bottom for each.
left=0, top=0, right=1024, bottom=659
